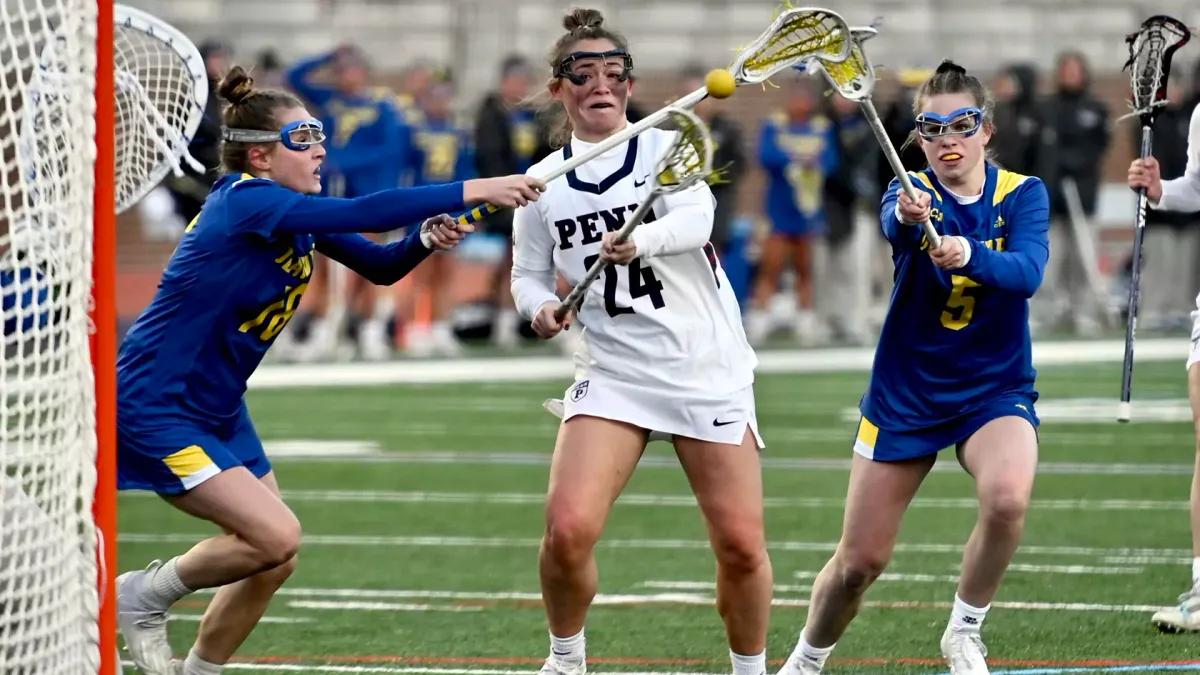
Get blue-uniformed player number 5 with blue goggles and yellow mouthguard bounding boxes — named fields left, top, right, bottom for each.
left=781, top=61, right=1049, bottom=675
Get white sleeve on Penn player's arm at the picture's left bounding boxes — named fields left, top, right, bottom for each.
left=510, top=204, right=558, bottom=321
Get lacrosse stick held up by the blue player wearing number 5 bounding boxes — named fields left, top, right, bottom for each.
left=803, top=26, right=942, bottom=249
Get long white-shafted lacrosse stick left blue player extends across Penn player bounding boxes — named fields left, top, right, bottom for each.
left=457, top=7, right=850, bottom=225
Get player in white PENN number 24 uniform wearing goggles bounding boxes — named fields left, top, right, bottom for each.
left=512, top=10, right=772, bottom=675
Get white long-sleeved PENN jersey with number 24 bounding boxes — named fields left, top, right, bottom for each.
left=512, top=129, right=757, bottom=396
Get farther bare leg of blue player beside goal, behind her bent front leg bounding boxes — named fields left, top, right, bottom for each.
left=182, top=472, right=296, bottom=675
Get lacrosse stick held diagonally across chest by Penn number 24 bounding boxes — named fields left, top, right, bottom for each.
left=554, top=108, right=713, bottom=322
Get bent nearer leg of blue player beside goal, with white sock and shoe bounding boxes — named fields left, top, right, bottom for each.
left=116, top=467, right=300, bottom=675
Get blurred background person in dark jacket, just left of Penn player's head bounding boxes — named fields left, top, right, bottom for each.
left=475, top=55, right=539, bottom=347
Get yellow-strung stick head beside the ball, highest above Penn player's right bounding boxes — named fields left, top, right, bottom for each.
left=728, top=7, right=850, bottom=84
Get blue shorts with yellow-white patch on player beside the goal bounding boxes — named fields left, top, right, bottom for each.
left=116, top=406, right=271, bottom=495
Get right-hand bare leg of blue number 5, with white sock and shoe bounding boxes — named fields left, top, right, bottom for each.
left=942, top=416, right=1038, bottom=675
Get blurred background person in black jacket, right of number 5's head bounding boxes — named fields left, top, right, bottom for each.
left=1037, top=52, right=1109, bottom=334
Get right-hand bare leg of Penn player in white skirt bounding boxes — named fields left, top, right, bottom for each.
left=674, top=428, right=773, bottom=675
